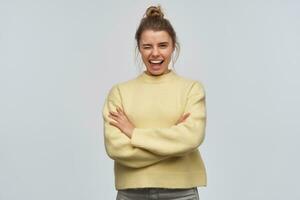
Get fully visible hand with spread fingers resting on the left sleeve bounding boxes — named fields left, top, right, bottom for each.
left=108, top=107, right=135, bottom=138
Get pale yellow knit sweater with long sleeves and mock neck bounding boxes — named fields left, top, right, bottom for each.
left=102, top=70, right=207, bottom=190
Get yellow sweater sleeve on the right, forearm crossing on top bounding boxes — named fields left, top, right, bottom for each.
left=131, top=81, right=206, bottom=156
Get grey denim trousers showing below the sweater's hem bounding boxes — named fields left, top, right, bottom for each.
left=116, top=187, right=199, bottom=200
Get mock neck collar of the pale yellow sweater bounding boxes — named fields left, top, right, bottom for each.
left=138, top=69, right=177, bottom=83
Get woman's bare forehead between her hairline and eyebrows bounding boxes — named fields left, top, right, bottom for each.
left=141, top=30, right=172, bottom=44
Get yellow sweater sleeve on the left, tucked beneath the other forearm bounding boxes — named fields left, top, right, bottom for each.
left=102, top=85, right=169, bottom=168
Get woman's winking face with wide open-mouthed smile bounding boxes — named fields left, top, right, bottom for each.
left=139, top=30, right=174, bottom=75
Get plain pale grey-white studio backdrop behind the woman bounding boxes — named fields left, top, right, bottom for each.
left=0, top=0, right=300, bottom=200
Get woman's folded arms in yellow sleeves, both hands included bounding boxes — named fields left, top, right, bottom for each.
left=102, top=81, right=206, bottom=168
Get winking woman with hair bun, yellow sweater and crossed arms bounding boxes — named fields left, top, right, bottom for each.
left=102, top=6, right=207, bottom=200
